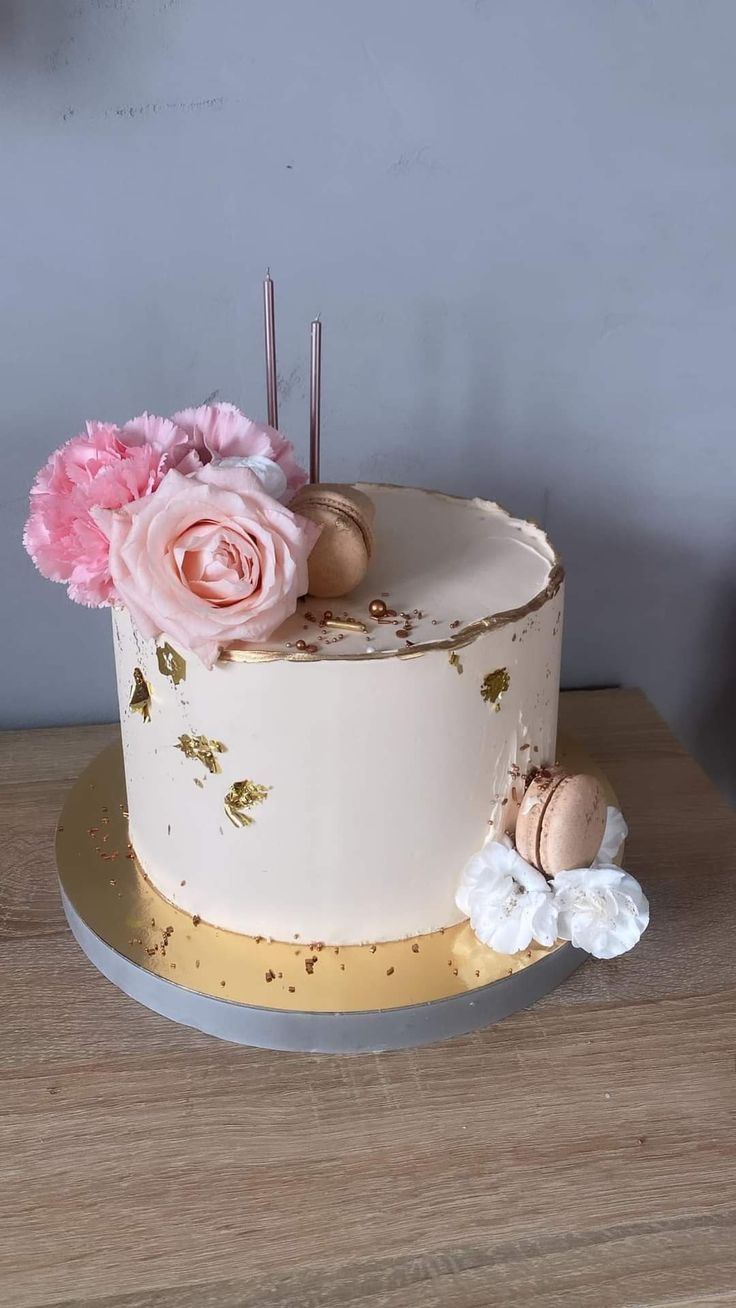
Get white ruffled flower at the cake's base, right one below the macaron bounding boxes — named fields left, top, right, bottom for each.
left=552, top=861, right=650, bottom=959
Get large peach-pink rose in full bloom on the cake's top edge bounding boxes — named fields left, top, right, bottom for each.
left=97, top=464, right=319, bottom=667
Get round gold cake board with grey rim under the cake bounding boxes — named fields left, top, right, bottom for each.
left=56, top=740, right=614, bottom=1053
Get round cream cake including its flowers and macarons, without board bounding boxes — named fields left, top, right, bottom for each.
left=25, top=392, right=648, bottom=984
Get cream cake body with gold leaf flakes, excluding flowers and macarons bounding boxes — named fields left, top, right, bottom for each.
left=114, top=485, right=563, bottom=944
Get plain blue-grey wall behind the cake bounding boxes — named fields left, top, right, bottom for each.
left=0, top=0, right=736, bottom=786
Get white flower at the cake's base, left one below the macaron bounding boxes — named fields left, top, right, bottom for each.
left=455, top=840, right=557, bottom=954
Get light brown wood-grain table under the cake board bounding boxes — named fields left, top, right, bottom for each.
left=0, top=691, right=736, bottom=1308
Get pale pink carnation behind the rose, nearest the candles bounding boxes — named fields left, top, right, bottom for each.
left=173, top=404, right=307, bottom=498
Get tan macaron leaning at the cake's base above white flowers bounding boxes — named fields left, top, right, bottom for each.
left=515, top=768, right=607, bottom=876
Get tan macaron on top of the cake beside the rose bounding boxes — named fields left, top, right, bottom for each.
left=289, top=483, right=375, bottom=599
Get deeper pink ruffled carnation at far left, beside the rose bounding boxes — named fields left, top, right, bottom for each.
left=24, top=422, right=166, bottom=607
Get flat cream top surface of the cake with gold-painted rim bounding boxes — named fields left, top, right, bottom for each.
left=224, top=483, right=562, bottom=661
